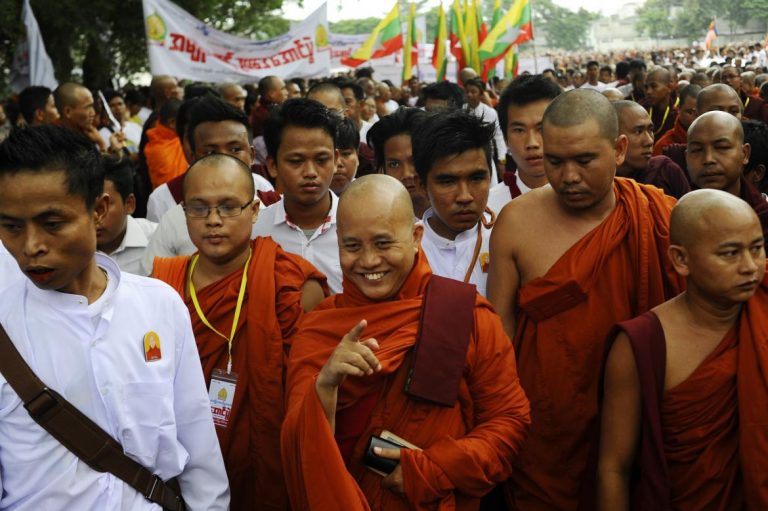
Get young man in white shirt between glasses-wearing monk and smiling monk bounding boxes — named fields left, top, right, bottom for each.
left=253, top=99, right=341, bottom=293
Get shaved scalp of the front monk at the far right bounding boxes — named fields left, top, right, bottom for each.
left=669, top=189, right=760, bottom=247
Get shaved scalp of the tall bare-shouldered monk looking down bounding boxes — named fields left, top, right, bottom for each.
left=542, top=89, right=619, bottom=143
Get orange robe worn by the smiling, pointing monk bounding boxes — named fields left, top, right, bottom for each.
left=282, top=253, right=529, bottom=511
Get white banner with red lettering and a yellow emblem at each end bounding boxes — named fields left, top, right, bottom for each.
left=143, top=0, right=331, bottom=83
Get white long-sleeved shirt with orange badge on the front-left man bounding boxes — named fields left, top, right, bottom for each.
left=0, top=254, right=229, bottom=511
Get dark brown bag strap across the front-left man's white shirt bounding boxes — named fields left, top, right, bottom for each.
left=0, top=325, right=185, bottom=511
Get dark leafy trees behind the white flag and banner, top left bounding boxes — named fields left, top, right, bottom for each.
left=0, top=0, right=288, bottom=88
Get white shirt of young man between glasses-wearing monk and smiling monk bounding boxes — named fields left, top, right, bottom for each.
left=251, top=192, right=341, bottom=293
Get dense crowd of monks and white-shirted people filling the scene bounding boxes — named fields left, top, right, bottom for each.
left=0, top=44, right=768, bottom=511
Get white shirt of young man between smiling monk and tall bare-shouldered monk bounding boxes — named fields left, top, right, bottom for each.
left=418, top=208, right=492, bottom=296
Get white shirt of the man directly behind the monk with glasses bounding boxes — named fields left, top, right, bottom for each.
left=140, top=174, right=274, bottom=275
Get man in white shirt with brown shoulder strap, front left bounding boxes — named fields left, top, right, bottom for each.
left=0, top=126, right=229, bottom=511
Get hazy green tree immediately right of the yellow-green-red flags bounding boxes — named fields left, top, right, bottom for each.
left=533, top=0, right=600, bottom=50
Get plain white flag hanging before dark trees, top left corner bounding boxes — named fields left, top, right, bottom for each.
left=11, top=0, right=59, bottom=93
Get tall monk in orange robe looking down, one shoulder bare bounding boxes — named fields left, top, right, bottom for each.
left=488, top=90, right=679, bottom=510
